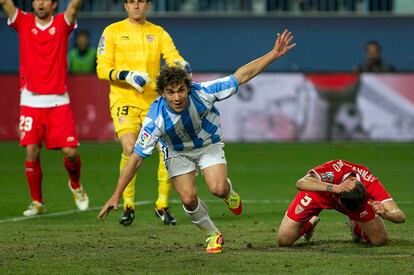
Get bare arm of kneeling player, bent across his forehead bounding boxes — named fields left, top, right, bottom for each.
left=296, top=174, right=355, bottom=193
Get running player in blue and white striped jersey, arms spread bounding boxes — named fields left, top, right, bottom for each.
left=98, top=30, right=296, bottom=253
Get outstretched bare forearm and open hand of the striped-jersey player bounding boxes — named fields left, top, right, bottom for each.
left=234, top=30, right=296, bottom=85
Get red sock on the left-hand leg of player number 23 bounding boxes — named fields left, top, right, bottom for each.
left=24, top=160, right=43, bottom=203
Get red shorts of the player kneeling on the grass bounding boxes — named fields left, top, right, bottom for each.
left=286, top=191, right=375, bottom=222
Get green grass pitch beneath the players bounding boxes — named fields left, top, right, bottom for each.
left=0, top=142, right=414, bottom=274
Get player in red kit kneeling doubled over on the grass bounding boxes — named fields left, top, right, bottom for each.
left=277, top=160, right=405, bottom=246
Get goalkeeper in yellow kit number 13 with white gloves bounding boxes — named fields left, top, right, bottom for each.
left=96, top=0, right=191, bottom=226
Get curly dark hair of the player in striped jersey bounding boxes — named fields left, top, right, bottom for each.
left=156, top=66, right=191, bottom=95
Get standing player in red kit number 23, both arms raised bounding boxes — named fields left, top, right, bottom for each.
left=0, top=0, right=89, bottom=216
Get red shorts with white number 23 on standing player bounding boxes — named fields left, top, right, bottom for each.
left=19, top=104, right=79, bottom=149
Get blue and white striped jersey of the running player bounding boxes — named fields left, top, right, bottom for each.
left=134, top=75, right=239, bottom=158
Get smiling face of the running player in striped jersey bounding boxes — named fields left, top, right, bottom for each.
left=162, top=83, right=189, bottom=113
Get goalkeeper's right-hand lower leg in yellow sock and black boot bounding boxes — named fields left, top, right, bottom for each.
left=155, top=150, right=177, bottom=225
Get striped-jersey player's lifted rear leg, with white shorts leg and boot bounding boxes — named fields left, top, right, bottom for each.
left=198, top=144, right=243, bottom=215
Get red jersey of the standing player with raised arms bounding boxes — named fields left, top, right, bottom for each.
left=9, top=9, right=75, bottom=94
